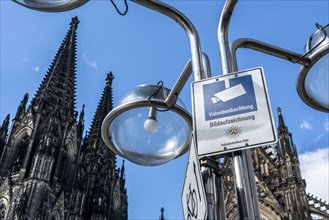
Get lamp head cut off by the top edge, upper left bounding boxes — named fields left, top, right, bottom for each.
left=13, top=0, right=89, bottom=12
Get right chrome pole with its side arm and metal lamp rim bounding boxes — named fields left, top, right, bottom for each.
left=218, top=0, right=329, bottom=219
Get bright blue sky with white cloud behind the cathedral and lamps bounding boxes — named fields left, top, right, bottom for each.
left=0, top=0, right=329, bottom=219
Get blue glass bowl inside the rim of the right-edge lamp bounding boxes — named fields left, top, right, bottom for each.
left=305, top=54, right=329, bottom=109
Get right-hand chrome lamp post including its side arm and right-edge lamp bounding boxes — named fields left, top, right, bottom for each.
left=218, top=0, right=329, bottom=219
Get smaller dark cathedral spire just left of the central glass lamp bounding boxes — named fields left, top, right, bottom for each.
left=87, top=72, right=114, bottom=147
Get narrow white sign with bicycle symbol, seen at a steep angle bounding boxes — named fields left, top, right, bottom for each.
left=182, top=138, right=207, bottom=220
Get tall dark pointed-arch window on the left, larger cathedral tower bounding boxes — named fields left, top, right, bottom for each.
left=11, top=135, right=29, bottom=173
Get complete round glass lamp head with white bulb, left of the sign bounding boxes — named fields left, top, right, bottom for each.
left=102, top=85, right=192, bottom=166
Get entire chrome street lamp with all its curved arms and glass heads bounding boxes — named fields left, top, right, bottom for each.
left=14, top=0, right=329, bottom=219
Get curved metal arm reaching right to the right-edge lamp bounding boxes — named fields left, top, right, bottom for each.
left=231, top=38, right=311, bottom=71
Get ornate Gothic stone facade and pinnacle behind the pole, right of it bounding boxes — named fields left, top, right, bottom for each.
left=223, top=108, right=329, bottom=220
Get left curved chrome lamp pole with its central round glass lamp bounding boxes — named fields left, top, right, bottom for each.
left=102, top=0, right=209, bottom=166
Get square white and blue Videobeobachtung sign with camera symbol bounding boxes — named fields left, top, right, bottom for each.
left=192, top=68, right=277, bottom=156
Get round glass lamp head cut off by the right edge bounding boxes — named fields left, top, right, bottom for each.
left=297, top=24, right=329, bottom=112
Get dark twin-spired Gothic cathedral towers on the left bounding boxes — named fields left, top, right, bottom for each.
left=0, top=17, right=128, bottom=220
